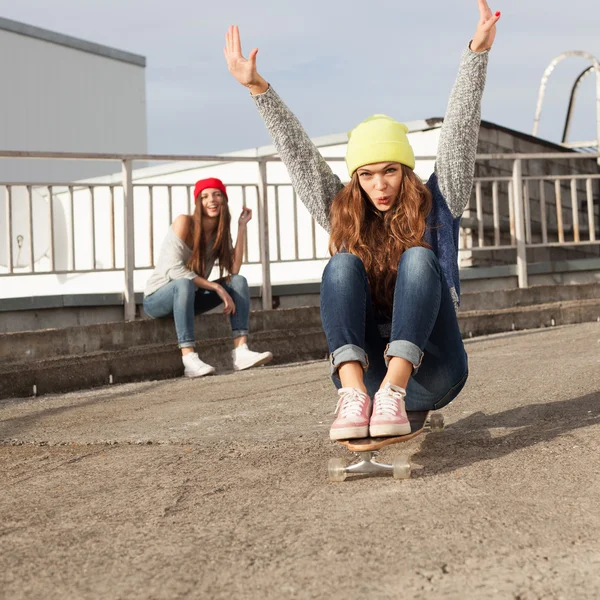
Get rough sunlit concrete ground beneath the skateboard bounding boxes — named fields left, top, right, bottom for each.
left=0, top=323, right=600, bottom=600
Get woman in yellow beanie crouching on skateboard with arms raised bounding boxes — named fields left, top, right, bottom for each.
left=225, top=0, right=500, bottom=439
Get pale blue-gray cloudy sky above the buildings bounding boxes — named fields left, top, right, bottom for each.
left=0, top=0, right=600, bottom=154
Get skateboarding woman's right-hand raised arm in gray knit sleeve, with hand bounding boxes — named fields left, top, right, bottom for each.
left=435, top=0, right=500, bottom=217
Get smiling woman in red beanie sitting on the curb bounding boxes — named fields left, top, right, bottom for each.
left=144, top=177, right=273, bottom=377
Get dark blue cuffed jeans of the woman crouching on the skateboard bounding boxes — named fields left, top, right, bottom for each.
left=321, top=247, right=468, bottom=410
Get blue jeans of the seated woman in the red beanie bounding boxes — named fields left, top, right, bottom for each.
left=144, top=275, right=250, bottom=348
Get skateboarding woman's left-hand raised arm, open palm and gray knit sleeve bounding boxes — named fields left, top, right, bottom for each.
left=225, top=26, right=343, bottom=231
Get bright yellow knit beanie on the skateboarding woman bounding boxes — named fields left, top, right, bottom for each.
left=346, top=115, right=415, bottom=177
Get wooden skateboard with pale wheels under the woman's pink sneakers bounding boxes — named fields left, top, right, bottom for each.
left=327, top=411, right=444, bottom=481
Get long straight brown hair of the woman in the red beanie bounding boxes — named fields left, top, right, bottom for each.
left=187, top=194, right=233, bottom=278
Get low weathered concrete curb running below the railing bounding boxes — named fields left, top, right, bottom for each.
left=0, top=299, right=600, bottom=399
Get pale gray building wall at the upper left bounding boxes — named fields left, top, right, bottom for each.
left=0, top=30, right=147, bottom=182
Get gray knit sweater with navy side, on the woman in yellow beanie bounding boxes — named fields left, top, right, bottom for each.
left=253, top=48, right=488, bottom=322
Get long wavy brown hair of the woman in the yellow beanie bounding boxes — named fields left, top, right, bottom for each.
left=329, top=165, right=432, bottom=318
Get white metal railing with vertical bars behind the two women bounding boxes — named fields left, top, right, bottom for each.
left=0, top=151, right=600, bottom=320
